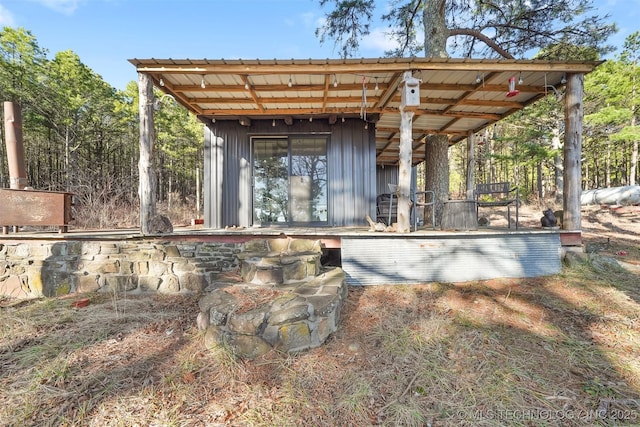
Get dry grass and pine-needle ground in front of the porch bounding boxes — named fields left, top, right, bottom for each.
left=0, top=206, right=640, bottom=426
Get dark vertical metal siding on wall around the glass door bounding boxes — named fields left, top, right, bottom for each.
left=204, top=119, right=377, bottom=228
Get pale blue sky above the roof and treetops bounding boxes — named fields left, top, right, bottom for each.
left=0, top=0, right=640, bottom=89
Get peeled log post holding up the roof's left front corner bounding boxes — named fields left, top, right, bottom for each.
left=138, top=73, right=156, bottom=234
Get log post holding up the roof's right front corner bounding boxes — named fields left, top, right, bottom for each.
left=562, top=74, right=584, bottom=231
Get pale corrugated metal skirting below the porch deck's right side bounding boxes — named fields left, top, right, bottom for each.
left=342, top=233, right=562, bottom=285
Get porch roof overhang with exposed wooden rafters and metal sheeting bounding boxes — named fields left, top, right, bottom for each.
left=129, top=58, right=601, bottom=164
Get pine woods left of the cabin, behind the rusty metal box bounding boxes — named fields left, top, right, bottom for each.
left=0, top=27, right=203, bottom=227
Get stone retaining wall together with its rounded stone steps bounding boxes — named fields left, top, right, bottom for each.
left=0, top=238, right=347, bottom=358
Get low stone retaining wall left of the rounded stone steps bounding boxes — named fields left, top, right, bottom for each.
left=0, top=240, right=244, bottom=298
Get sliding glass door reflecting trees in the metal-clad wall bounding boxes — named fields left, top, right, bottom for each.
left=253, top=137, right=328, bottom=224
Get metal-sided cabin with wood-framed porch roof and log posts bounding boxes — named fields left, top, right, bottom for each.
left=130, top=58, right=598, bottom=237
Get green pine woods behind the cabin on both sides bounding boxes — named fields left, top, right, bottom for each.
left=0, top=22, right=640, bottom=231
